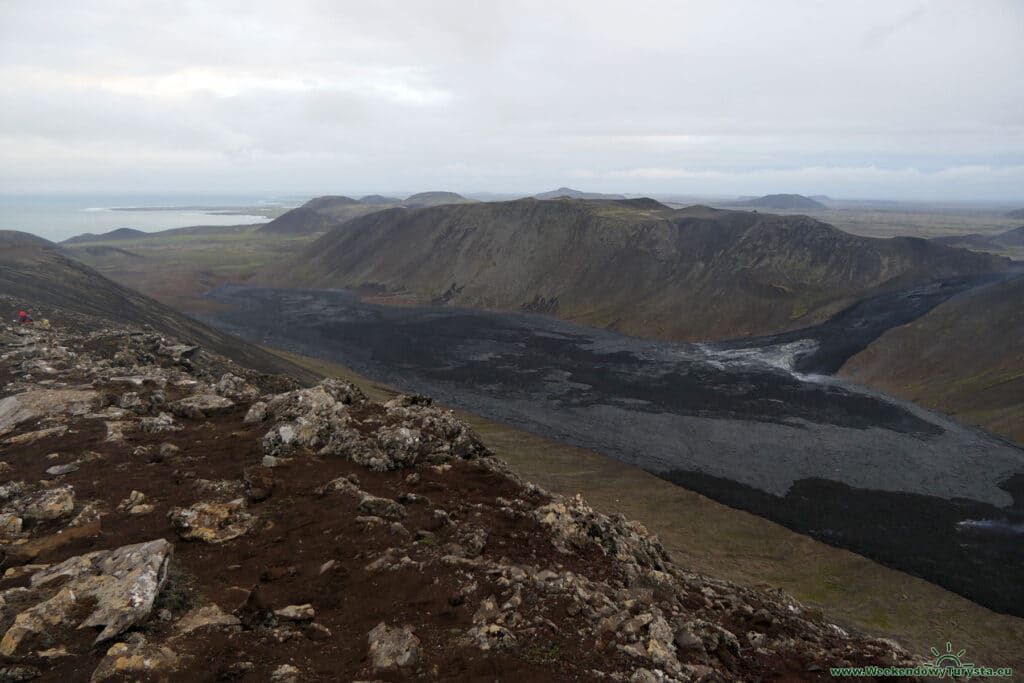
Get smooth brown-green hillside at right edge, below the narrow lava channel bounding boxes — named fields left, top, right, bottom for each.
left=842, top=276, right=1024, bottom=443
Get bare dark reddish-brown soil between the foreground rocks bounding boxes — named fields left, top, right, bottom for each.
left=0, top=407, right=625, bottom=681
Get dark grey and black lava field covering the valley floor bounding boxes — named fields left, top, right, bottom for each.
left=197, top=288, right=1024, bottom=614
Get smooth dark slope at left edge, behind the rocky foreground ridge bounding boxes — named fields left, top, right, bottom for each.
left=0, top=231, right=313, bottom=381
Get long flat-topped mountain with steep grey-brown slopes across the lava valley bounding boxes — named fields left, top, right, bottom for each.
left=262, top=199, right=1009, bottom=340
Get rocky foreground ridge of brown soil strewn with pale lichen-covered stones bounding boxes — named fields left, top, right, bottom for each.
left=0, top=299, right=929, bottom=682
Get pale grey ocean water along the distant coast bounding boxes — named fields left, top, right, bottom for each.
left=0, top=195, right=300, bottom=242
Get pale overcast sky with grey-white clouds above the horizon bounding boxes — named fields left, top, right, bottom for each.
left=0, top=0, right=1024, bottom=200
